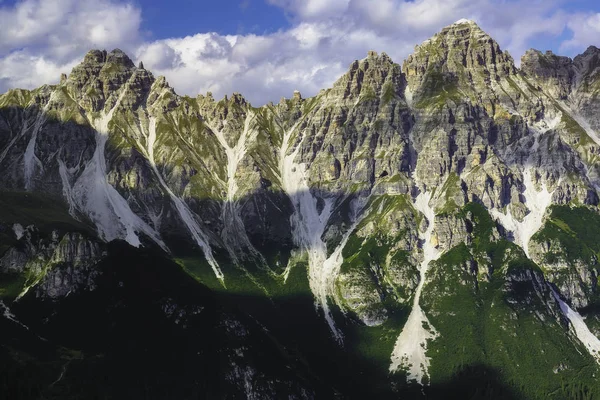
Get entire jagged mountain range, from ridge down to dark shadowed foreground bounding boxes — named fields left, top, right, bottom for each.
left=0, top=20, right=600, bottom=399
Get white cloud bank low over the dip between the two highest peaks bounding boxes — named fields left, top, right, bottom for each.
left=136, top=27, right=345, bottom=104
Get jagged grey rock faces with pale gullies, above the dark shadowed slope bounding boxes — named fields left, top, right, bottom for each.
left=0, top=20, right=600, bottom=400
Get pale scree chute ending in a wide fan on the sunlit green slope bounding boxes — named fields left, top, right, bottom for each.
left=390, top=192, right=440, bottom=384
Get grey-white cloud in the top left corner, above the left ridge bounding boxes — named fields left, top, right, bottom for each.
left=0, top=0, right=141, bottom=91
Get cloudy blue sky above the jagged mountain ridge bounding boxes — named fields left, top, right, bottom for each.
left=0, top=0, right=600, bottom=105
